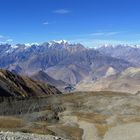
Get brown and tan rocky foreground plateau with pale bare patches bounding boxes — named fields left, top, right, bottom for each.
left=0, top=91, right=140, bottom=140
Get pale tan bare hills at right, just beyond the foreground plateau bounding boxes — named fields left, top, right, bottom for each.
left=76, top=68, right=140, bottom=93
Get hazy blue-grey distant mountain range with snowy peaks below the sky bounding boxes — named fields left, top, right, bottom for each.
left=0, top=40, right=137, bottom=85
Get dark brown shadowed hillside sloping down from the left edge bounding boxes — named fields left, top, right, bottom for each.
left=0, top=69, right=61, bottom=97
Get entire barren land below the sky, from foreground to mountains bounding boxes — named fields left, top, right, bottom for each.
left=0, top=44, right=140, bottom=140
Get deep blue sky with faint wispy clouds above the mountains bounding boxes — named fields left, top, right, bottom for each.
left=0, top=0, right=140, bottom=47
